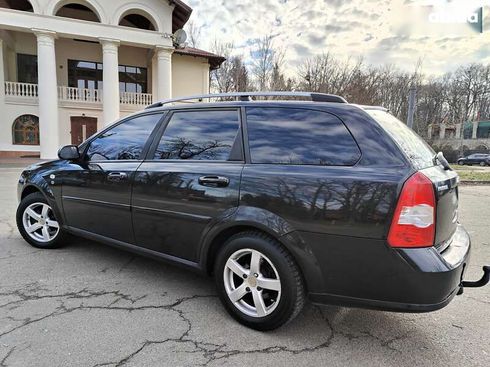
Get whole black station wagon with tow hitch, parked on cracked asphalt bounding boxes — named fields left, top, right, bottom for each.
left=17, top=92, right=489, bottom=330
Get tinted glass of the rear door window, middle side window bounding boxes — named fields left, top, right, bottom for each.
left=155, top=110, right=239, bottom=160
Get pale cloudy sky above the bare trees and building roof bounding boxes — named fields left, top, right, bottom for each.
left=186, top=0, right=490, bottom=75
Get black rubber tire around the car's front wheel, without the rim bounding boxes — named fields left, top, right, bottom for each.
left=16, top=192, right=66, bottom=249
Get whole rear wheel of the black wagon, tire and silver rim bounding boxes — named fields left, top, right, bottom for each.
left=214, top=232, right=305, bottom=331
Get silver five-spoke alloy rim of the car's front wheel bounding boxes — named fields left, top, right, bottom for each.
left=22, top=203, right=60, bottom=243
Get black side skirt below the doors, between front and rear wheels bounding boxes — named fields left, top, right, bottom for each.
left=63, top=226, right=205, bottom=274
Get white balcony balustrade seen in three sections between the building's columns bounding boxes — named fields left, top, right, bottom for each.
left=5, top=82, right=153, bottom=107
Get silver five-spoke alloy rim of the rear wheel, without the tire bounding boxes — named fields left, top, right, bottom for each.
left=223, top=249, right=281, bottom=317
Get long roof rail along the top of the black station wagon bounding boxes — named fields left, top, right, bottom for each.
left=146, top=92, right=347, bottom=109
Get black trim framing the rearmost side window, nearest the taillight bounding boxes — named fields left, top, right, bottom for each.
left=242, top=105, right=363, bottom=168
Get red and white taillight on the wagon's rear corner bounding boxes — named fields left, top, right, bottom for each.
left=388, top=172, right=436, bottom=247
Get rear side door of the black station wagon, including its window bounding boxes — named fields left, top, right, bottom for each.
left=132, top=108, right=243, bottom=262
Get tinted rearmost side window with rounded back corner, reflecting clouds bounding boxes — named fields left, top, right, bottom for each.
left=247, top=107, right=361, bottom=166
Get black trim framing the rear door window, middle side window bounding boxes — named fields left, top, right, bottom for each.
left=145, top=107, right=245, bottom=164
